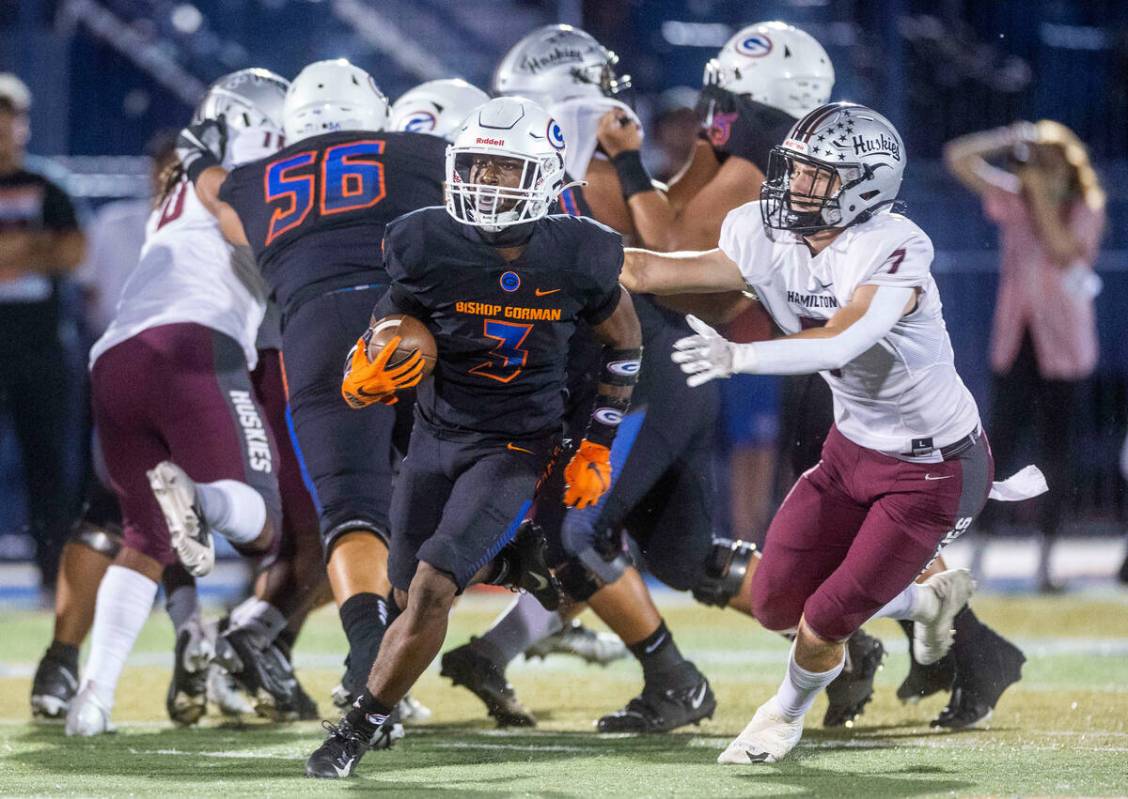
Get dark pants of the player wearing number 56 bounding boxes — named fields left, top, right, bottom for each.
left=282, top=286, right=412, bottom=555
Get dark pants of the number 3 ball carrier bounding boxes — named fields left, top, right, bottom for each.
left=388, top=418, right=558, bottom=592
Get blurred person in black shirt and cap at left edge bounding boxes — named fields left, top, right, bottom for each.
left=0, top=73, right=85, bottom=586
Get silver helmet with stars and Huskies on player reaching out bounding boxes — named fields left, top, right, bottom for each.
left=760, top=103, right=907, bottom=234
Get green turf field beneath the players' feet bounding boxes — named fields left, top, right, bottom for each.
left=0, top=592, right=1128, bottom=799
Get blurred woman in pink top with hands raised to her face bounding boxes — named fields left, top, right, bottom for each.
left=944, top=120, right=1104, bottom=591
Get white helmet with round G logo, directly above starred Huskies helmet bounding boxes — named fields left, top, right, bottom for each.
left=705, top=23, right=835, bottom=117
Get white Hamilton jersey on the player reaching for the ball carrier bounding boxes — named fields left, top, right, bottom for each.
left=720, top=202, right=979, bottom=458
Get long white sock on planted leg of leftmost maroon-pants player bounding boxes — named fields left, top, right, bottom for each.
left=82, top=565, right=157, bottom=708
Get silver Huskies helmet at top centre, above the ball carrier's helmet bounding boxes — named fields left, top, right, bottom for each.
left=493, top=25, right=631, bottom=106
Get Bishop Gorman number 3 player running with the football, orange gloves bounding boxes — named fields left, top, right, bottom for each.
left=306, top=98, right=642, bottom=778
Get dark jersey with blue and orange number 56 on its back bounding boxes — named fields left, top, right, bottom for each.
left=220, top=131, right=447, bottom=308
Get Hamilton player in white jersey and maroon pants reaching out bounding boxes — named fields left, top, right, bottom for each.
left=624, top=103, right=1045, bottom=764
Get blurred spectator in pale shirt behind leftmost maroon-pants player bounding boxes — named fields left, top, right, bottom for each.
left=76, top=130, right=176, bottom=341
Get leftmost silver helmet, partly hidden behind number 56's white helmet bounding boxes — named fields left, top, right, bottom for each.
left=192, top=67, right=290, bottom=167
